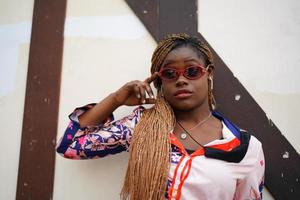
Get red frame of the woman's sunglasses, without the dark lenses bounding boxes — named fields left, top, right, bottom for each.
left=158, top=64, right=207, bottom=81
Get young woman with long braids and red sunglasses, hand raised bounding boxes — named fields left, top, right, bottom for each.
left=57, top=34, right=265, bottom=200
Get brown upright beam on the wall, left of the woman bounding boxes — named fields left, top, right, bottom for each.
left=16, top=0, right=66, bottom=199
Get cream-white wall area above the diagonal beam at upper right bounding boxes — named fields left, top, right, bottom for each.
left=198, top=0, right=300, bottom=198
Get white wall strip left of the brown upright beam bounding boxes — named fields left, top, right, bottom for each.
left=0, top=0, right=33, bottom=200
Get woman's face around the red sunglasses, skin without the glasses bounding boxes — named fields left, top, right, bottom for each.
left=162, top=46, right=209, bottom=111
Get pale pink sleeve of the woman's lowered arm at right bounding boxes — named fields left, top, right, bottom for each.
left=234, top=143, right=265, bottom=200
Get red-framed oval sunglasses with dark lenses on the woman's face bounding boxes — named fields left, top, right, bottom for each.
left=158, top=65, right=206, bottom=81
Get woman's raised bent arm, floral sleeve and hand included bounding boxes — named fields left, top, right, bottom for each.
left=56, top=74, right=157, bottom=159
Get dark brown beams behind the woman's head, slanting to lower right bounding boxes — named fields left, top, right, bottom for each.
left=126, top=0, right=300, bottom=199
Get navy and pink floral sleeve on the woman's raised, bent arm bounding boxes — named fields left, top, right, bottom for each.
left=56, top=104, right=145, bottom=159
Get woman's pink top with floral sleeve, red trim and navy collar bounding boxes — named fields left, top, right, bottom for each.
left=57, top=104, right=265, bottom=200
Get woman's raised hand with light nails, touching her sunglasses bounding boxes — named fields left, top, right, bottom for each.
left=114, top=72, right=158, bottom=106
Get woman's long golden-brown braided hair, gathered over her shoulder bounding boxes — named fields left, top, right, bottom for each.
left=121, top=34, right=213, bottom=200
